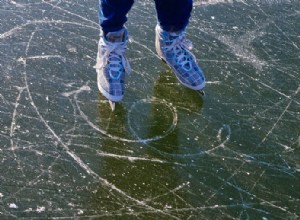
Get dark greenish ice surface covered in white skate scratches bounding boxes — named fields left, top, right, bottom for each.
left=0, top=0, right=300, bottom=220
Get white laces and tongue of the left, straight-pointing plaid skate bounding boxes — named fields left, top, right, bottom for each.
left=95, top=42, right=131, bottom=80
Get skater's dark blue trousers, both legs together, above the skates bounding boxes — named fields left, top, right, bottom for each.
left=99, top=0, right=193, bottom=33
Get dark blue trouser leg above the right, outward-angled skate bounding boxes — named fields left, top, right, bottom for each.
left=155, top=0, right=193, bottom=32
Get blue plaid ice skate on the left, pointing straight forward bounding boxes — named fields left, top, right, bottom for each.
left=95, top=28, right=130, bottom=110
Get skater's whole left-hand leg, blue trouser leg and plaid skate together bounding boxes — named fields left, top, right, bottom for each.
left=95, top=0, right=134, bottom=109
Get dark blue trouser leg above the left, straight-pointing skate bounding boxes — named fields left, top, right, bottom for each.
left=99, top=0, right=134, bottom=33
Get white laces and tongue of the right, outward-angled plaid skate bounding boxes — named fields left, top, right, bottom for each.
left=163, top=33, right=194, bottom=71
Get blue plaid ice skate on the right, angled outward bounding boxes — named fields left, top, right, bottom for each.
left=155, top=25, right=205, bottom=95
